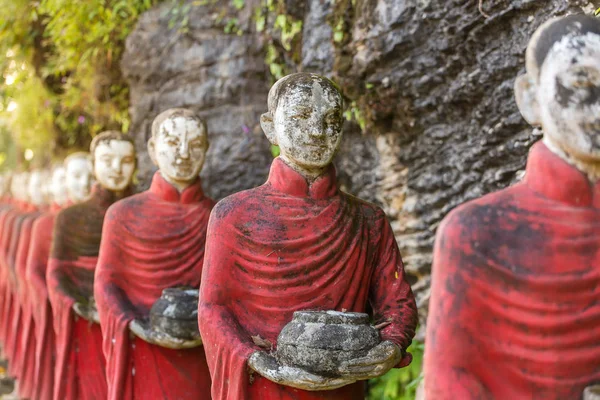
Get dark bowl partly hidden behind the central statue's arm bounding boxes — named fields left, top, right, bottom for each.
left=150, top=287, right=200, bottom=340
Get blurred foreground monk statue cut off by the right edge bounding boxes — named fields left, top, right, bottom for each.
left=424, top=15, right=600, bottom=400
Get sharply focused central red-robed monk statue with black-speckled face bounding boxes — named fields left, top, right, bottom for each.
left=198, top=73, right=417, bottom=400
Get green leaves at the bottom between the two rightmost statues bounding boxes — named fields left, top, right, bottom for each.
left=368, top=343, right=424, bottom=400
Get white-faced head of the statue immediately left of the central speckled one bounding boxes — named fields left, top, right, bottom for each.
left=148, top=108, right=208, bottom=190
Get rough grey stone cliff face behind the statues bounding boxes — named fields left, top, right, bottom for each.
left=122, top=0, right=600, bottom=332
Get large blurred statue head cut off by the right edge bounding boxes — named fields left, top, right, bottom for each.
left=515, top=15, right=600, bottom=163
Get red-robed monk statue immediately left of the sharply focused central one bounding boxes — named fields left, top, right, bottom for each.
left=94, top=109, right=214, bottom=400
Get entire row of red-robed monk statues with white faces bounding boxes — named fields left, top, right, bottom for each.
left=0, top=16, right=600, bottom=400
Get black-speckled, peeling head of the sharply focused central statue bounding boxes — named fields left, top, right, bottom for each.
left=260, top=72, right=343, bottom=177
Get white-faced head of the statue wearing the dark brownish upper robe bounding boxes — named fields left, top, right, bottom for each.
left=90, top=131, right=136, bottom=192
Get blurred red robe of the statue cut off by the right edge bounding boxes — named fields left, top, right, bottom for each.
left=424, top=143, right=600, bottom=400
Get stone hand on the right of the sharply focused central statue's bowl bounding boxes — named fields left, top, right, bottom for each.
left=339, top=340, right=403, bottom=380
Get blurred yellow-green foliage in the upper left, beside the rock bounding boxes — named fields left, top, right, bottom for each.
left=0, top=0, right=161, bottom=169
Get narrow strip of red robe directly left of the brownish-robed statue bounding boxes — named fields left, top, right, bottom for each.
left=26, top=205, right=60, bottom=400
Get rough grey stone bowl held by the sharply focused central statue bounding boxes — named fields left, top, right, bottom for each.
left=276, top=311, right=381, bottom=377
